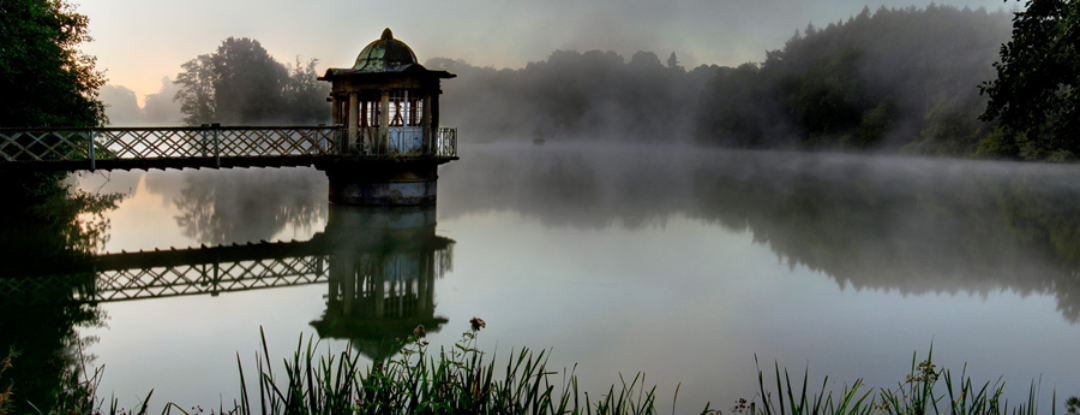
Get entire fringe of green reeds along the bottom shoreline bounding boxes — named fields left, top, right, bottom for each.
left=0, top=319, right=1080, bottom=415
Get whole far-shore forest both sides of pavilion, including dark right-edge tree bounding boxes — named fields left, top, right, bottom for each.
left=95, top=0, right=1080, bottom=161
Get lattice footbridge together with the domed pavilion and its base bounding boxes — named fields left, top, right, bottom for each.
left=0, top=28, right=458, bottom=205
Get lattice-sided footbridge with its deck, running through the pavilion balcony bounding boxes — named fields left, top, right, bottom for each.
left=0, top=125, right=457, bottom=171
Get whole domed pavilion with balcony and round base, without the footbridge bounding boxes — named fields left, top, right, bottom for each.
left=315, top=28, right=458, bottom=205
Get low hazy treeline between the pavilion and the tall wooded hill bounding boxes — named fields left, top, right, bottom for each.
left=426, top=51, right=719, bottom=142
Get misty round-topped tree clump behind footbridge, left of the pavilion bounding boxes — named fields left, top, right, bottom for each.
left=175, top=38, right=329, bottom=125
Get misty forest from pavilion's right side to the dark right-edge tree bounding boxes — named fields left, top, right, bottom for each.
left=427, top=5, right=1012, bottom=156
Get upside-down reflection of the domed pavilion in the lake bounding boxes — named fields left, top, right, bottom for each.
left=311, top=204, right=454, bottom=360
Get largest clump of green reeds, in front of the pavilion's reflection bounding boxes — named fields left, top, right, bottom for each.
left=226, top=319, right=710, bottom=415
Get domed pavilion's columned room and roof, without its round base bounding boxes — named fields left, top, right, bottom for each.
left=319, top=28, right=456, bottom=156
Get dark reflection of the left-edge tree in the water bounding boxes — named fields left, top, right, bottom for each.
left=0, top=191, right=121, bottom=413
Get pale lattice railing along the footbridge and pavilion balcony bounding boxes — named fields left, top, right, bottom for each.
left=0, top=124, right=457, bottom=169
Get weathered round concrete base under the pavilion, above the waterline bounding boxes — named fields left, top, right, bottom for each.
left=323, top=162, right=438, bottom=206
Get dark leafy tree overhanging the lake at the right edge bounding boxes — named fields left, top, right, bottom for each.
left=981, top=0, right=1080, bottom=159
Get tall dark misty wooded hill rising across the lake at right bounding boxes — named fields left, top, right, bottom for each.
left=696, top=4, right=1008, bottom=155
